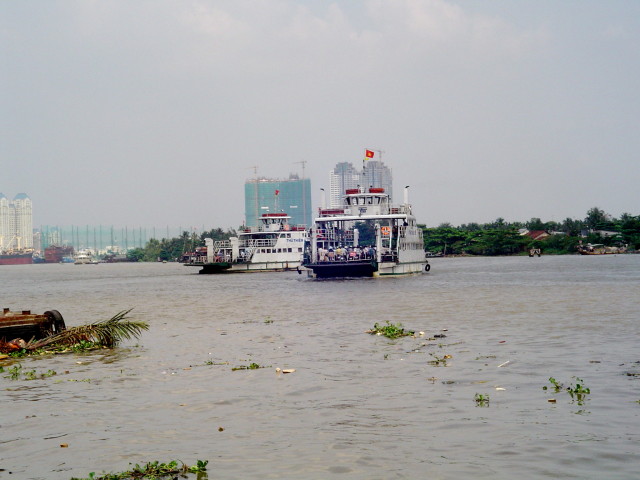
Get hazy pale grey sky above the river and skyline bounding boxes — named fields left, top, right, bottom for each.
left=0, top=0, right=640, bottom=229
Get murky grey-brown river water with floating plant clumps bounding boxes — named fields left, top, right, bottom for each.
left=0, top=255, right=640, bottom=480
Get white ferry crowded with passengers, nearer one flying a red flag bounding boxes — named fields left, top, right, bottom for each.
left=302, top=187, right=430, bottom=278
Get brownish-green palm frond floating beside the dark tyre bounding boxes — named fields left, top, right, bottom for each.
left=26, top=309, right=149, bottom=350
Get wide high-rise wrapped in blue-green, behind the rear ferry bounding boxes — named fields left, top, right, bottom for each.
left=244, top=174, right=313, bottom=227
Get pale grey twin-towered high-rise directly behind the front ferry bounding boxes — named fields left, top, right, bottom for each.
left=329, top=160, right=393, bottom=208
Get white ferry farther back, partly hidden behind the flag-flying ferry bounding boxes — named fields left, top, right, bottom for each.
left=182, top=213, right=307, bottom=273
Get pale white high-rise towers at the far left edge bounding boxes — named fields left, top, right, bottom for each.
left=0, top=193, right=33, bottom=250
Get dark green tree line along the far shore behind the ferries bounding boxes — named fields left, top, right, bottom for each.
left=122, top=207, right=640, bottom=262
